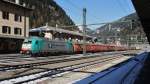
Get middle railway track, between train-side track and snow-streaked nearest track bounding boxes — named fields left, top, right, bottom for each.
left=0, top=52, right=133, bottom=71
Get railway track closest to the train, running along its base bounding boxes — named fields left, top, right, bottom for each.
left=0, top=51, right=137, bottom=62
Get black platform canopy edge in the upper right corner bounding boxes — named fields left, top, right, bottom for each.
left=132, top=0, right=150, bottom=43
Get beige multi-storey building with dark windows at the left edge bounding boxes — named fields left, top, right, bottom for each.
left=0, top=0, right=32, bottom=53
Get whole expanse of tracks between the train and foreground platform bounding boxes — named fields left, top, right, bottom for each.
left=0, top=50, right=139, bottom=84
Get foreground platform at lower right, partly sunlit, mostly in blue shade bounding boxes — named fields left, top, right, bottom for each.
left=39, top=52, right=150, bottom=84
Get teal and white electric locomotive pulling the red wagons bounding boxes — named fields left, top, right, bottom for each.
left=21, top=37, right=73, bottom=56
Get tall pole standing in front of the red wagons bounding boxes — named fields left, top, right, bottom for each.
left=83, top=8, right=86, bottom=56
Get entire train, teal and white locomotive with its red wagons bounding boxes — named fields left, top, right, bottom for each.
left=21, top=37, right=127, bottom=56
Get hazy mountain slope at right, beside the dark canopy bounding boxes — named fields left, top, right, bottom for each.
left=93, top=13, right=145, bottom=43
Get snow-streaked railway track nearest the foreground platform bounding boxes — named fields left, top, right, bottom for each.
left=0, top=55, right=121, bottom=84
